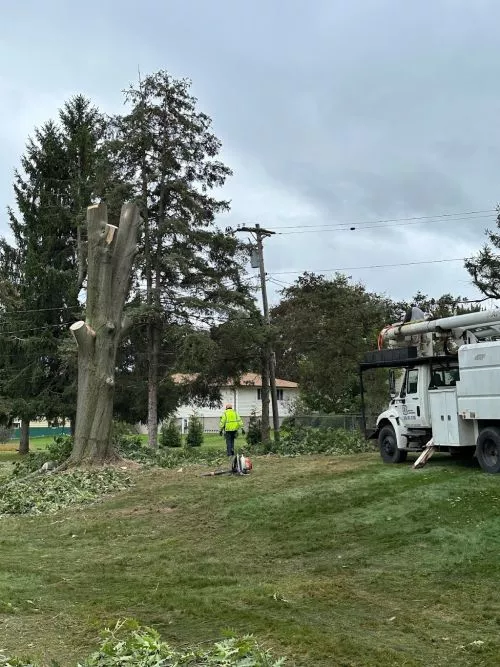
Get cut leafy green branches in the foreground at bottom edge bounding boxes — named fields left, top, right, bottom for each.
left=0, top=621, right=285, bottom=667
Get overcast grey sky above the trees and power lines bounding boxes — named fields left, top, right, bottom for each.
left=0, top=0, right=500, bottom=306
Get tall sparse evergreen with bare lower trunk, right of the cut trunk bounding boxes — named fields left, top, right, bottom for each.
left=110, top=71, right=256, bottom=448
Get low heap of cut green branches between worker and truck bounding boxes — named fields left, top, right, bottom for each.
left=257, top=426, right=374, bottom=456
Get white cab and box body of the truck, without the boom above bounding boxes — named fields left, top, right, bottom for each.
left=360, top=341, right=500, bottom=473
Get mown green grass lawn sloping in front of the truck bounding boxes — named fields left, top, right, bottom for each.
left=0, top=454, right=500, bottom=667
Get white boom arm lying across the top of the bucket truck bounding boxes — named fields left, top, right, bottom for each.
left=380, top=310, right=500, bottom=341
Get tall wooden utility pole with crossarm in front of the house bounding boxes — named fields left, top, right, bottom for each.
left=236, top=224, right=280, bottom=442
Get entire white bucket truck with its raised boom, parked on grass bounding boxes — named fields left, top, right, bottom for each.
left=360, top=309, right=500, bottom=473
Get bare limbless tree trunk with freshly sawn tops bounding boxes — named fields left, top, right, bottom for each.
left=69, top=204, right=140, bottom=465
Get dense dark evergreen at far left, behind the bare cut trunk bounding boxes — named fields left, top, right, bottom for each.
left=0, top=96, right=113, bottom=451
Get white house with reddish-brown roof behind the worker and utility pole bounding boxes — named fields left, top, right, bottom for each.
left=173, top=373, right=299, bottom=432
